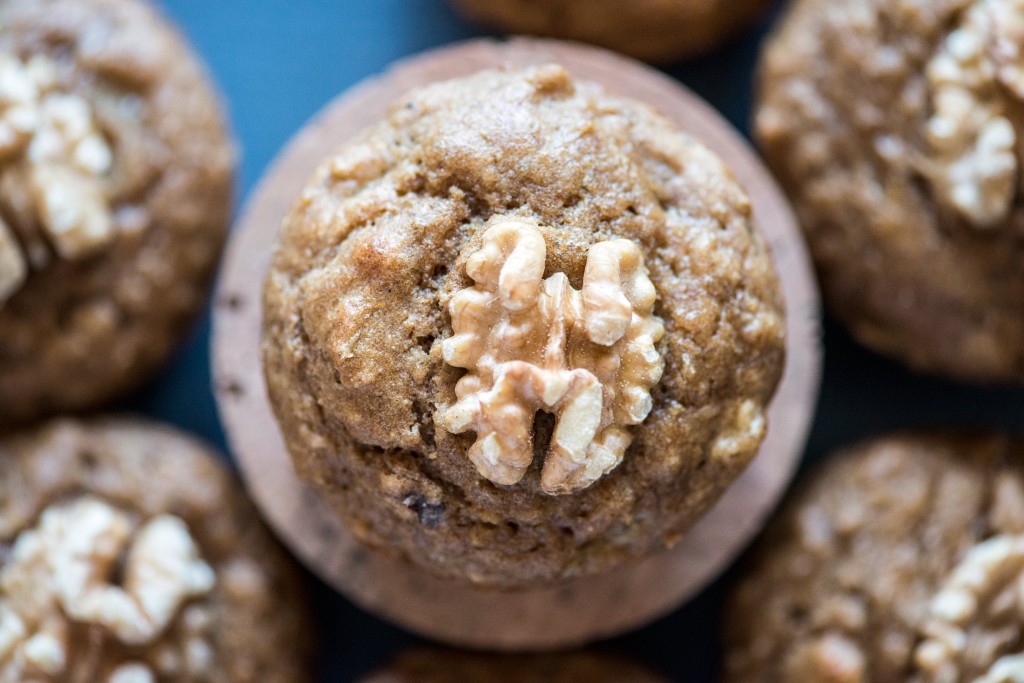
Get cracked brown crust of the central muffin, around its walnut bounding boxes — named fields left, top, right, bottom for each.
left=262, top=65, right=784, bottom=587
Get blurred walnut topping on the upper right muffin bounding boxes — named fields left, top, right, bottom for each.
left=925, top=0, right=1024, bottom=228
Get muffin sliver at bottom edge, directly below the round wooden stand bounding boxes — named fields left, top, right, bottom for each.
left=359, top=649, right=665, bottom=683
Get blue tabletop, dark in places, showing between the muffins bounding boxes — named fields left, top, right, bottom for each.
left=118, top=0, right=1024, bottom=681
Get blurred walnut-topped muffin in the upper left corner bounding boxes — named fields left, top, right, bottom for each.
left=0, top=0, right=234, bottom=424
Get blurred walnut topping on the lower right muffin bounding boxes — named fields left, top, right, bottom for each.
left=914, top=536, right=1024, bottom=683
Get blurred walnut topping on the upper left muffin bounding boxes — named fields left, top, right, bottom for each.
left=0, top=53, right=115, bottom=301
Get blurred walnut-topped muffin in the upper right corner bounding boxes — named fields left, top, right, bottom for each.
left=755, top=0, right=1024, bottom=383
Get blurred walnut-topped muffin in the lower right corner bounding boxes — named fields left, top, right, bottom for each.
left=724, top=434, right=1024, bottom=683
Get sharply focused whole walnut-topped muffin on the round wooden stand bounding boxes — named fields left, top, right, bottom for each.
left=262, top=65, right=784, bottom=588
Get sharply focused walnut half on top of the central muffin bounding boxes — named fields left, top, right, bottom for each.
left=442, top=218, right=664, bottom=494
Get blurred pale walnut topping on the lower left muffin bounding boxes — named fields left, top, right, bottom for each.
left=0, top=497, right=214, bottom=683
